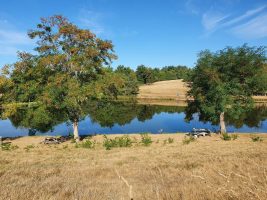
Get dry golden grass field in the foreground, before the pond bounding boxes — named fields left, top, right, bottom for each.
left=0, top=134, right=267, bottom=200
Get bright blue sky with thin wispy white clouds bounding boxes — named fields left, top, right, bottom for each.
left=0, top=0, right=267, bottom=69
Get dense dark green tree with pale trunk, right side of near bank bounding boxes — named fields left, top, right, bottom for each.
left=187, top=45, right=267, bottom=133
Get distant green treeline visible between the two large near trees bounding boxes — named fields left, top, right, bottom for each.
left=103, top=65, right=192, bottom=96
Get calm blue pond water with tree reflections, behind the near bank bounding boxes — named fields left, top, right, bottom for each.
left=0, top=102, right=267, bottom=137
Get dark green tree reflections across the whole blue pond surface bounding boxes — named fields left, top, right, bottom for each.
left=3, top=101, right=267, bottom=135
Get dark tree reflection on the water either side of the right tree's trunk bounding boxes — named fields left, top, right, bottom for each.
left=185, top=102, right=267, bottom=128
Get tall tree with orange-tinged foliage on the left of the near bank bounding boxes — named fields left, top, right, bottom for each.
left=4, top=15, right=116, bottom=140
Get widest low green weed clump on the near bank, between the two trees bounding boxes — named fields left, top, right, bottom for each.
left=103, top=135, right=133, bottom=150
